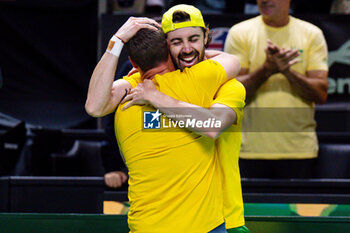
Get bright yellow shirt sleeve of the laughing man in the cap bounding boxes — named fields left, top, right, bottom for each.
left=212, top=79, right=246, bottom=124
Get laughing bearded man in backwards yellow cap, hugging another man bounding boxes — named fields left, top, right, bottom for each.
left=121, top=4, right=249, bottom=233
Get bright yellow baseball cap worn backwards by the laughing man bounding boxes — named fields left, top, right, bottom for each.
left=162, top=4, right=205, bottom=33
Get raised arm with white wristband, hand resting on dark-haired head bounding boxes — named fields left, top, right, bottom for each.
left=85, top=17, right=159, bottom=117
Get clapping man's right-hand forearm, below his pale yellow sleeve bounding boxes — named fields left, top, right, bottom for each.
left=283, top=69, right=328, bottom=104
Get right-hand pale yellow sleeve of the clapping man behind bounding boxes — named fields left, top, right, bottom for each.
left=306, top=30, right=328, bottom=71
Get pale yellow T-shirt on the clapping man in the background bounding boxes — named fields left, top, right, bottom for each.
left=225, top=16, right=328, bottom=159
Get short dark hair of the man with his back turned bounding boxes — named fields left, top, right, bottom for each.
left=125, top=25, right=169, bottom=72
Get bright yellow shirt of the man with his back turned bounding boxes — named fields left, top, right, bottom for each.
left=115, top=60, right=227, bottom=233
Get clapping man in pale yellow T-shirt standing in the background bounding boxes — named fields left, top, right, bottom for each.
left=225, top=0, right=328, bottom=178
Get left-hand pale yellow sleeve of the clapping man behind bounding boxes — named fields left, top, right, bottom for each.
left=224, top=26, right=249, bottom=68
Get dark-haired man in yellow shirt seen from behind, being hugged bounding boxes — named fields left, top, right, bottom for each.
left=86, top=15, right=239, bottom=233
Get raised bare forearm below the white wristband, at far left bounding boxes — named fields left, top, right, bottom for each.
left=85, top=52, right=119, bottom=117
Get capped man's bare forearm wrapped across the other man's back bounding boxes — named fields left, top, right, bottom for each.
left=147, top=91, right=236, bottom=139
